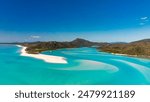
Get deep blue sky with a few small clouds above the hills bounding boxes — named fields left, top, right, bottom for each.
left=0, top=0, right=150, bottom=42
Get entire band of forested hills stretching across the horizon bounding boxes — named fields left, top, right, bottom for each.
left=1, top=38, right=150, bottom=58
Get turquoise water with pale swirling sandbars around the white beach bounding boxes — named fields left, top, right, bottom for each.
left=0, top=45, right=150, bottom=85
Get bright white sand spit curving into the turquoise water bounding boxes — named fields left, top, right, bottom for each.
left=17, top=45, right=67, bottom=64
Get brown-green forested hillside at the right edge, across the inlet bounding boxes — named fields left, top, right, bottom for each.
left=100, top=39, right=150, bottom=57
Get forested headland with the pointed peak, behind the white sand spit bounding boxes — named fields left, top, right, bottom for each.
left=21, top=38, right=108, bottom=54
